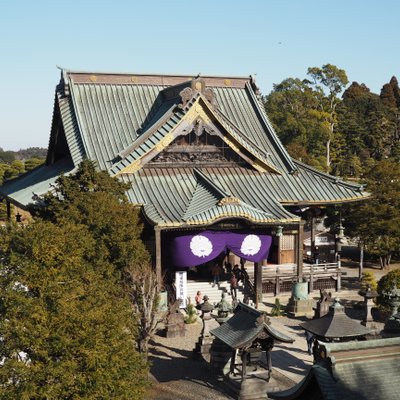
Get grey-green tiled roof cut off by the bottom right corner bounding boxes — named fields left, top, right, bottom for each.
left=268, top=338, right=400, bottom=400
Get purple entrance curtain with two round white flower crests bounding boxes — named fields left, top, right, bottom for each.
left=170, top=231, right=272, bottom=267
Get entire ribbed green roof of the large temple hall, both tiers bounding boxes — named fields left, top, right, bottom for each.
left=0, top=70, right=368, bottom=220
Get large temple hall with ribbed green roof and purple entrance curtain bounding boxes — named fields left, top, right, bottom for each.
left=0, top=70, right=368, bottom=291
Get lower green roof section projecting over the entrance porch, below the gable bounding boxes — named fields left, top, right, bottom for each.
left=120, top=168, right=300, bottom=226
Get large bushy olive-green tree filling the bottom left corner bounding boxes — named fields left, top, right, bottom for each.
left=0, top=221, right=147, bottom=400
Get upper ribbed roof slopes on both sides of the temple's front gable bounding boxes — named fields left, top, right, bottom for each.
left=57, top=71, right=295, bottom=170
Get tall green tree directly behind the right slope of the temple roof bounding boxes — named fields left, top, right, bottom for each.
left=265, top=64, right=348, bottom=171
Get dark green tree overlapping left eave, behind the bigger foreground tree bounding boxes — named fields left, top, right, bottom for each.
left=31, top=160, right=149, bottom=271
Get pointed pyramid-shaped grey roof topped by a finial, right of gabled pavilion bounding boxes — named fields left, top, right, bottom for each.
left=300, top=299, right=371, bottom=339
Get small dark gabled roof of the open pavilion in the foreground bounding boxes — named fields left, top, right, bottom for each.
left=210, top=303, right=294, bottom=349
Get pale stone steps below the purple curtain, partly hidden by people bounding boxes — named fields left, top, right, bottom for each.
left=187, top=280, right=252, bottom=304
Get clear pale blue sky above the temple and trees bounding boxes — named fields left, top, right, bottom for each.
left=0, top=0, right=400, bottom=150
